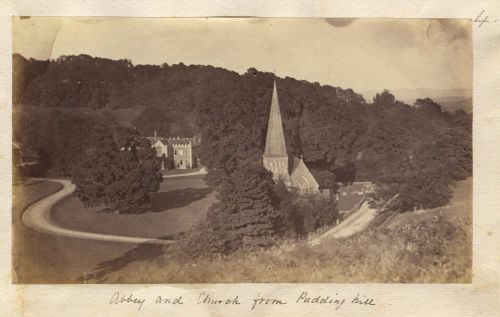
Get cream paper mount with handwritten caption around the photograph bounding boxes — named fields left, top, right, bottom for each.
left=0, top=0, right=500, bottom=316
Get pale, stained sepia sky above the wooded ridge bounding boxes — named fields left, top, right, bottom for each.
left=13, top=17, right=472, bottom=92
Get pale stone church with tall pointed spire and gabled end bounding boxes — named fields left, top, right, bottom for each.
left=262, top=81, right=319, bottom=194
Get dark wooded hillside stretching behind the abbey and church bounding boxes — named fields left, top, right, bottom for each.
left=13, top=54, right=472, bottom=186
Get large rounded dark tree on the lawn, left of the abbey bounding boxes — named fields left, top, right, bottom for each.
left=72, top=127, right=162, bottom=213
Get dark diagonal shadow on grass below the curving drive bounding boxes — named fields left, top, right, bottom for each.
left=84, top=236, right=172, bottom=283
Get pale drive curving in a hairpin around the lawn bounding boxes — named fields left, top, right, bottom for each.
left=22, top=179, right=176, bottom=244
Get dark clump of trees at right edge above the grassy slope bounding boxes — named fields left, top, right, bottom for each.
left=374, top=118, right=472, bottom=211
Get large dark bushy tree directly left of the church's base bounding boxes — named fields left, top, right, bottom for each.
left=190, top=164, right=284, bottom=253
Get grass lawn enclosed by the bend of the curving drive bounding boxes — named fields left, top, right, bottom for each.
left=51, top=175, right=215, bottom=238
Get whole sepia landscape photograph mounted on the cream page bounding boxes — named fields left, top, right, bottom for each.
left=9, top=16, right=473, bottom=284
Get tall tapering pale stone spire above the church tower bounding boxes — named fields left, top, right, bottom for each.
left=264, top=80, right=288, bottom=157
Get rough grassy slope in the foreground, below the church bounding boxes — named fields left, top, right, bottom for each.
left=96, top=180, right=472, bottom=283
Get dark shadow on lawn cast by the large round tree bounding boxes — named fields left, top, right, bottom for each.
left=149, top=188, right=212, bottom=212
